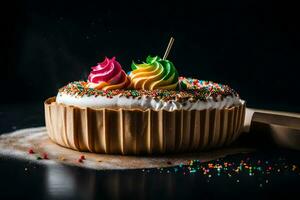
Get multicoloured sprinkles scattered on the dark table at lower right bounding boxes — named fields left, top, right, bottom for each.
left=142, top=154, right=300, bottom=187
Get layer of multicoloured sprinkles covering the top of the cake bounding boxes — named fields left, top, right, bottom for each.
left=59, top=79, right=239, bottom=102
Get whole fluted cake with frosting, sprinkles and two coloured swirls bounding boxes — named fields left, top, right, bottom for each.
left=45, top=57, right=245, bottom=154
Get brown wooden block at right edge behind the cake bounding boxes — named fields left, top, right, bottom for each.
left=244, top=108, right=300, bottom=150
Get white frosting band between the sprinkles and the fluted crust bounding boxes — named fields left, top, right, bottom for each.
left=56, top=93, right=244, bottom=111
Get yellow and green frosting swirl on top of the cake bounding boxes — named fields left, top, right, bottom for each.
left=129, top=56, right=178, bottom=90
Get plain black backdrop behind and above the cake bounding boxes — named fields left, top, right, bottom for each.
left=0, top=0, right=300, bottom=112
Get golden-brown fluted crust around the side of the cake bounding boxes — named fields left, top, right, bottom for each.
left=44, top=97, right=245, bottom=155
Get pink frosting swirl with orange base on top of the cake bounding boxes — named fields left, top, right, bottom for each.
left=88, top=57, right=130, bottom=90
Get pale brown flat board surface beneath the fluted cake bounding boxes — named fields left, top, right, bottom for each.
left=0, top=127, right=256, bottom=169
